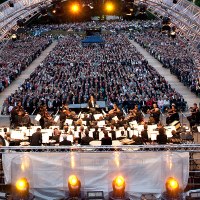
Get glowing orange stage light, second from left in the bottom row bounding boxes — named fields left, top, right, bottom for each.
left=68, top=175, right=81, bottom=198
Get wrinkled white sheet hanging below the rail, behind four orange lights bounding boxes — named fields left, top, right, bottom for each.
left=3, top=151, right=189, bottom=200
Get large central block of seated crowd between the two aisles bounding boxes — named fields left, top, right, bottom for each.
left=4, top=29, right=185, bottom=114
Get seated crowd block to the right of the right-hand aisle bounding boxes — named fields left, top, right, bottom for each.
left=133, top=26, right=200, bottom=96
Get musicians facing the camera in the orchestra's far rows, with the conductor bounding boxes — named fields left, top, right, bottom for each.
left=11, top=101, right=188, bottom=129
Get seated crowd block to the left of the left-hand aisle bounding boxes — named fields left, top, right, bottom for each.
left=0, top=35, right=52, bottom=113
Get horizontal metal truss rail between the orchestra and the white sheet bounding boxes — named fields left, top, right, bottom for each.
left=0, top=144, right=200, bottom=153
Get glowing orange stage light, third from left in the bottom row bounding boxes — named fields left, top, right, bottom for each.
left=110, top=176, right=126, bottom=200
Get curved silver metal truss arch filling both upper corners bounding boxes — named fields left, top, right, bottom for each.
left=0, top=0, right=200, bottom=67
